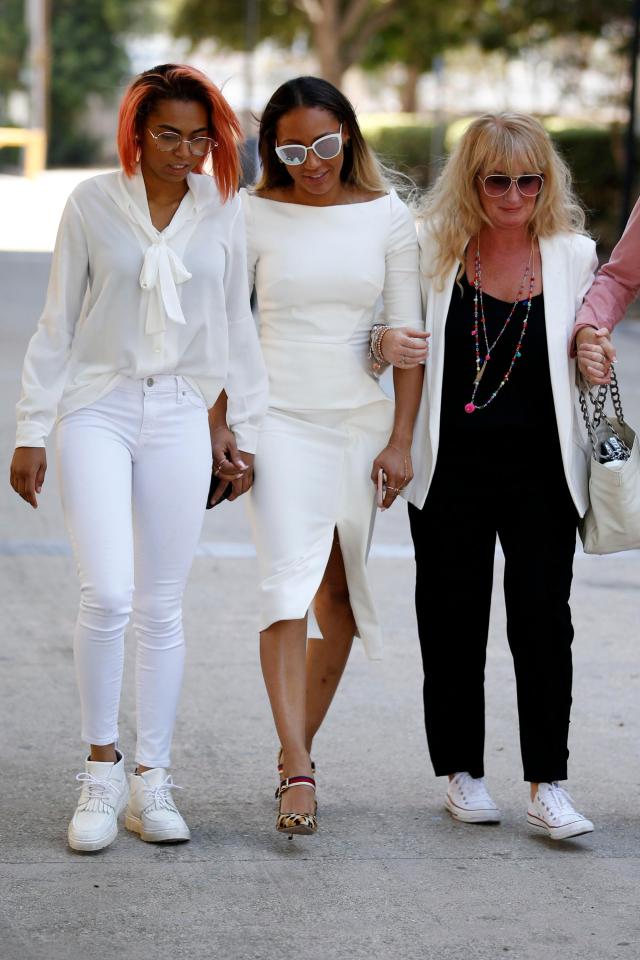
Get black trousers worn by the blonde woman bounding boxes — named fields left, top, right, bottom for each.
left=409, top=453, right=577, bottom=782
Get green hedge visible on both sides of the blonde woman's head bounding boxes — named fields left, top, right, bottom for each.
left=362, top=114, right=640, bottom=248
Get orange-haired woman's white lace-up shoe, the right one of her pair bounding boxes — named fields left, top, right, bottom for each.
left=124, top=767, right=191, bottom=843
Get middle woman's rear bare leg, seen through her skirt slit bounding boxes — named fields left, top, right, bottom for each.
left=305, top=532, right=356, bottom=751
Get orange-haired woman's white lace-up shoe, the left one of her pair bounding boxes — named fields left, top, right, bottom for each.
left=67, top=754, right=129, bottom=851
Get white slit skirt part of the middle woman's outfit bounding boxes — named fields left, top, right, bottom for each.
left=248, top=400, right=393, bottom=659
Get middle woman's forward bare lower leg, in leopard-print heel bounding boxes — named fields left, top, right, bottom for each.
left=260, top=617, right=315, bottom=813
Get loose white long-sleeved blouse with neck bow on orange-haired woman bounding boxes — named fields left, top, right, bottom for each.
left=16, top=171, right=268, bottom=453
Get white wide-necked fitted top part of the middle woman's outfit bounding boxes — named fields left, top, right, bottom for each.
left=240, top=190, right=424, bottom=410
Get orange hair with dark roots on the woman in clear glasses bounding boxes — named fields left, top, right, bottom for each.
left=118, top=63, right=242, bottom=200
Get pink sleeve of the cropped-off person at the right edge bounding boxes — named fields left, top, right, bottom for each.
left=572, top=200, right=640, bottom=339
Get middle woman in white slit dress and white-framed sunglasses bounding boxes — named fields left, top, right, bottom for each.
left=214, top=77, right=426, bottom=833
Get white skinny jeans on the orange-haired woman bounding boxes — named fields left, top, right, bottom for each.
left=57, top=376, right=211, bottom=767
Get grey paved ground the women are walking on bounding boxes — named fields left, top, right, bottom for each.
left=0, top=199, right=640, bottom=960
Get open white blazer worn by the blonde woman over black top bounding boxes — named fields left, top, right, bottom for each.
left=403, top=224, right=598, bottom=516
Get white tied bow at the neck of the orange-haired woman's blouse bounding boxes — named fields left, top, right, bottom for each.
left=114, top=173, right=191, bottom=336
